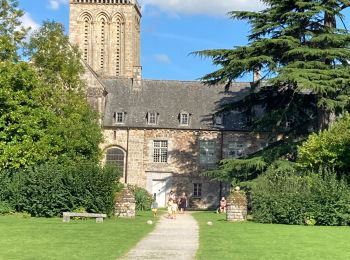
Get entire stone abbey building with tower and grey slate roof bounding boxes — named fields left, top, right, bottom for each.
left=70, top=0, right=266, bottom=208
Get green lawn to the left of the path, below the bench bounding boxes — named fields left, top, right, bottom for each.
left=0, top=212, right=159, bottom=260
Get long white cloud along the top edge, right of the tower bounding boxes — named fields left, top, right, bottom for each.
left=139, top=0, right=264, bottom=16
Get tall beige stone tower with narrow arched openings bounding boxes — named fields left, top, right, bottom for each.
left=69, top=0, right=141, bottom=81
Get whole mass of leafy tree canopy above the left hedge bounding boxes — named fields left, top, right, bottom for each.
left=0, top=0, right=102, bottom=169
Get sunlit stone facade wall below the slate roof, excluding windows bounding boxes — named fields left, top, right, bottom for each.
left=102, top=127, right=266, bottom=208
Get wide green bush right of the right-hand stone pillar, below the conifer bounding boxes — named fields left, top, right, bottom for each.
left=252, top=167, right=350, bottom=226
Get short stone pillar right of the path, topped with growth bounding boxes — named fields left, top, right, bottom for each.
left=226, top=187, right=248, bottom=222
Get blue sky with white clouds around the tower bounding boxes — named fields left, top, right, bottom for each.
left=19, top=0, right=350, bottom=81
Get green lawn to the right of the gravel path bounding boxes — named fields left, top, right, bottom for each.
left=193, top=212, right=350, bottom=260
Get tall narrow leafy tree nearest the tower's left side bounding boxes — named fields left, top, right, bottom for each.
left=27, top=22, right=102, bottom=165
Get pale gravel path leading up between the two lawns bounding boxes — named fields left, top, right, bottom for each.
left=122, top=213, right=199, bottom=260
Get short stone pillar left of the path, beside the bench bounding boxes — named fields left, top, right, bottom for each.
left=114, top=188, right=136, bottom=218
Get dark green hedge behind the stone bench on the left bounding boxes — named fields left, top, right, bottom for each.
left=0, top=162, right=120, bottom=217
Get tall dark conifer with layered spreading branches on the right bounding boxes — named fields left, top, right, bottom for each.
left=195, top=0, right=350, bottom=134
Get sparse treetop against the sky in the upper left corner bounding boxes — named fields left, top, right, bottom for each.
left=0, top=0, right=28, bottom=61
